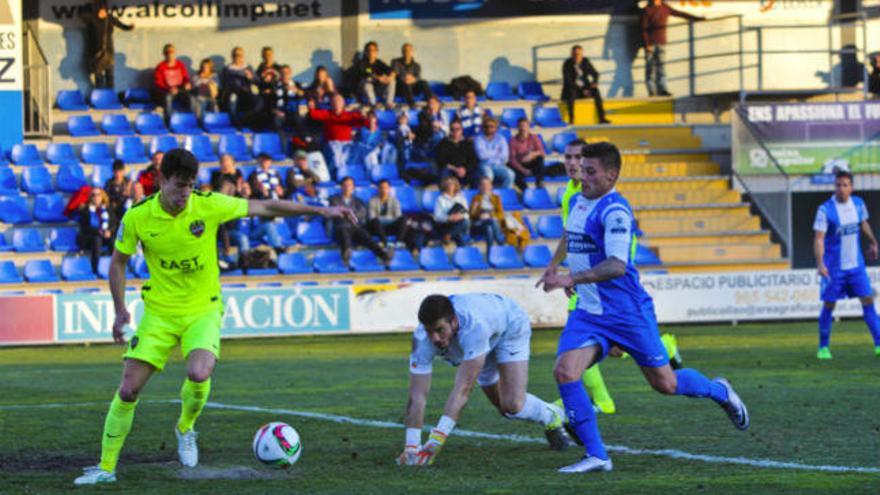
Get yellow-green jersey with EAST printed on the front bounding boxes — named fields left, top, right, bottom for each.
left=116, top=192, right=248, bottom=315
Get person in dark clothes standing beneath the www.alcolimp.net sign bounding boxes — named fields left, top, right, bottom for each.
left=81, top=0, right=134, bottom=89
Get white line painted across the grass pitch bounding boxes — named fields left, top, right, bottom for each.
left=0, top=399, right=880, bottom=473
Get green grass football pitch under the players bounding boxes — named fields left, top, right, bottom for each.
left=0, top=322, right=880, bottom=495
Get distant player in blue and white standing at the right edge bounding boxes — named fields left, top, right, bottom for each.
left=813, top=170, right=880, bottom=359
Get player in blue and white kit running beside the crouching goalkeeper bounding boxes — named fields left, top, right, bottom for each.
left=538, top=143, right=749, bottom=473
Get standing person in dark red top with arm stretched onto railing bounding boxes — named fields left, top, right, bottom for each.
left=639, top=0, right=706, bottom=96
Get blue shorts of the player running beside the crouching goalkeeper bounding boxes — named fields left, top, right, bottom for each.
left=556, top=305, right=669, bottom=368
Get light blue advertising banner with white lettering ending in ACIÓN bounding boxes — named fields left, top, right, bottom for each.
left=55, top=287, right=351, bottom=343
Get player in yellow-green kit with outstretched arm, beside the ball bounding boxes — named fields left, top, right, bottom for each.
left=74, top=149, right=356, bottom=485
